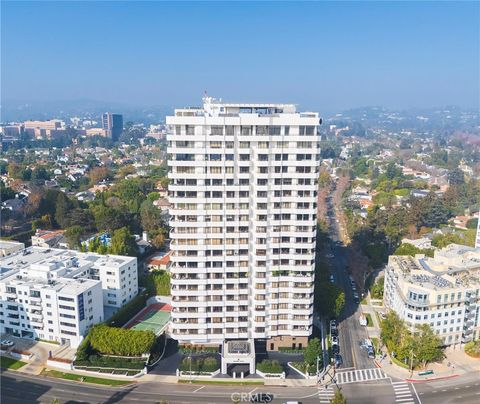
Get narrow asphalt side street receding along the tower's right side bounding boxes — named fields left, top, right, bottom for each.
left=327, top=199, right=375, bottom=369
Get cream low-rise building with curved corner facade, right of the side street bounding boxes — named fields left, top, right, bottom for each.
left=383, top=244, right=480, bottom=345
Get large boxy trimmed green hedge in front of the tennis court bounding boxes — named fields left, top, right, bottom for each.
left=89, top=324, right=155, bottom=356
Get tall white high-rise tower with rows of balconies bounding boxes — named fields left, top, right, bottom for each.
left=167, top=97, right=320, bottom=366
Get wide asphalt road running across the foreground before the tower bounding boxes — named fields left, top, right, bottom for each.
left=1, top=372, right=448, bottom=404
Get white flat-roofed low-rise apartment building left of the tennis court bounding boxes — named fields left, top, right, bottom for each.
left=0, top=247, right=138, bottom=347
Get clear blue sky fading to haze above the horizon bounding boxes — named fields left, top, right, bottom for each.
left=1, top=1, right=480, bottom=111
